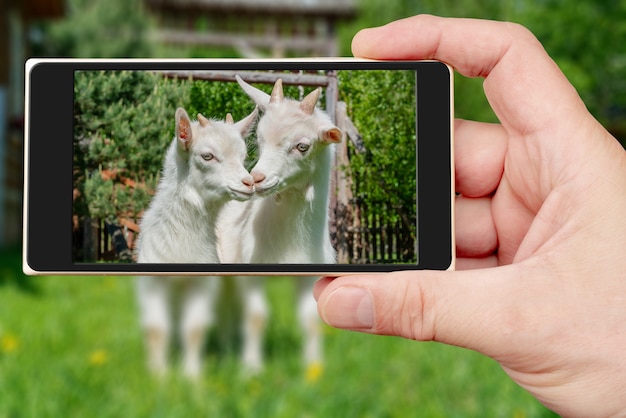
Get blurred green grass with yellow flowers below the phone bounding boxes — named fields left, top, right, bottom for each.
left=0, top=251, right=553, bottom=418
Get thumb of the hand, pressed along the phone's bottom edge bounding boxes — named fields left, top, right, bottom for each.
left=314, top=264, right=524, bottom=357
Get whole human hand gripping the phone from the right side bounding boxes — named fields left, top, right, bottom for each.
left=314, top=16, right=626, bottom=417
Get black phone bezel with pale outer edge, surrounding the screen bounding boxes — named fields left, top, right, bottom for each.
left=23, top=58, right=455, bottom=276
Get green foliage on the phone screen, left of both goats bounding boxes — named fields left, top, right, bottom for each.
left=74, top=71, right=185, bottom=219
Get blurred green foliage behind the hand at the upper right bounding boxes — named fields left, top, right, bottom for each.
left=338, top=0, right=626, bottom=144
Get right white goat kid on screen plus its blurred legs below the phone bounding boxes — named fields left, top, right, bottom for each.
left=218, top=77, right=343, bottom=371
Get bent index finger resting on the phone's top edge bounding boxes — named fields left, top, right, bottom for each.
left=352, top=15, right=586, bottom=135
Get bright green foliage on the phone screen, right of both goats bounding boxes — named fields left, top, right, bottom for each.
left=338, top=71, right=416, bottom=225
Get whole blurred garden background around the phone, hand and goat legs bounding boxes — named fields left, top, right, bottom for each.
left=0, top=0, right=626, bottom=417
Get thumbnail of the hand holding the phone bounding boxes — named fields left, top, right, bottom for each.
left=322, top=287, right=374, bottom=329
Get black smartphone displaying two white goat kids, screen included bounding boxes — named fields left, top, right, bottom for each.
left=23, top=58, right=455, bottom=275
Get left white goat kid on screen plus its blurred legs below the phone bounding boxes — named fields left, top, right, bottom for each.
left=137, top=108, right=257, bottom=377
